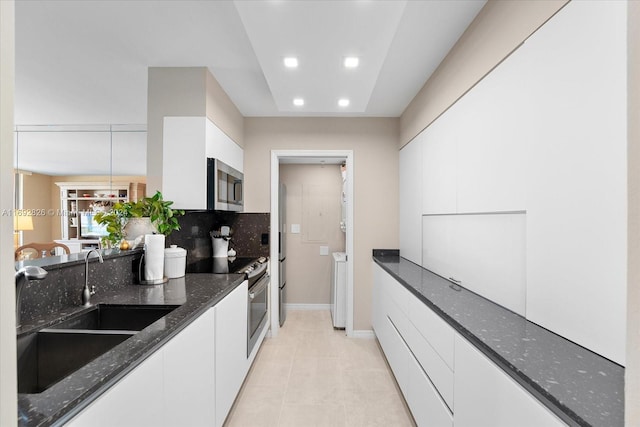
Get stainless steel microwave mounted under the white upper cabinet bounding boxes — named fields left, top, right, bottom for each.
left=207, top=158, right=244, bottom=212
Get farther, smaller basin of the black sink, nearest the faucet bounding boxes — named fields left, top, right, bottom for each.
left=50, top=304, right=178, bottom=331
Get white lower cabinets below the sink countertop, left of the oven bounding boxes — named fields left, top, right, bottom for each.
left=67, top=281, right=250, bottom=427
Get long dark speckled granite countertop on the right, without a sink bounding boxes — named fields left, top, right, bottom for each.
left=373, top=250, right=624, bottom=427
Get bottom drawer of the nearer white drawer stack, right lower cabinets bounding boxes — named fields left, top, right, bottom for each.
left=405, top=357, right=453, bottom=427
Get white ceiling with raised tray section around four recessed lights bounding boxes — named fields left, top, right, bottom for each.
left=15, top=0, right=485, bottom=125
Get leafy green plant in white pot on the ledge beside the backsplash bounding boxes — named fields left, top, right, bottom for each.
left=96, top=191, right=184, bottom=246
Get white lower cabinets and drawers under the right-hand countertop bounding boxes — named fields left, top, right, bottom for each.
left=372, top=263, right=565, bottom=427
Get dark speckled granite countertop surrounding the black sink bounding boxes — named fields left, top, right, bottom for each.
left=18, top=274, right=243, bottom=426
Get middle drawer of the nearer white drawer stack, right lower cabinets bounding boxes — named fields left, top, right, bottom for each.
left=405, top=324, right=454, bottom=411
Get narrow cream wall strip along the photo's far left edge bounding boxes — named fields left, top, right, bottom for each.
left=0, top=0, right=18, bottom=426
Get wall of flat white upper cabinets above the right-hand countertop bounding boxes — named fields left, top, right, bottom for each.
left=400, top=1, right=628, bottom=364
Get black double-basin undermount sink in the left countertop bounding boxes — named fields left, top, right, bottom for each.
left=17, top=304, right=178, bottom=393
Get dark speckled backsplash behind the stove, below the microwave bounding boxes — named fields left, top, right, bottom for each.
left=167, top=211, right=270, bottom=264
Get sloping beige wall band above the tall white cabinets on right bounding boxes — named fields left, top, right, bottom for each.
left=399, top=0, right=567, bottom=147
